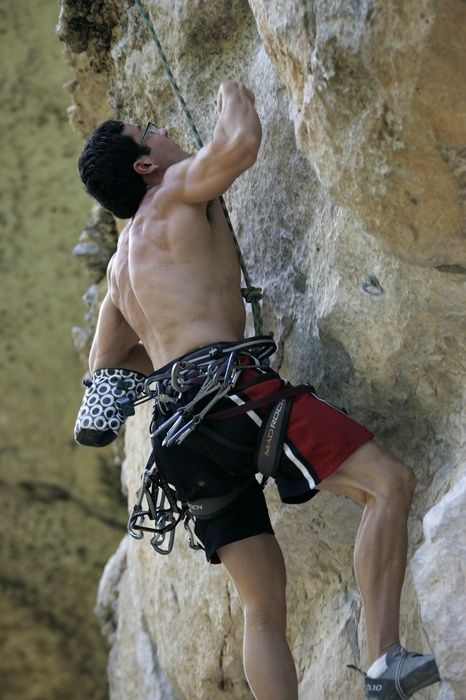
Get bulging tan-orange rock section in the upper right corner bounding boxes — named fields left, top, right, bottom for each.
left=251, top=0, right=466, bottom=266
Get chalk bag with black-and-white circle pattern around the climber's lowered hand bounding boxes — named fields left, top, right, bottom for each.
left=74, top=367, right=146, bottom=447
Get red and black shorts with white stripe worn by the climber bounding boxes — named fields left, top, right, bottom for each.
left=153, top=344, right=373, bottom=563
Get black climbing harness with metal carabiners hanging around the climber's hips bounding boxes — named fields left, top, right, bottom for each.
left=128, top=336, right=298, bottom=554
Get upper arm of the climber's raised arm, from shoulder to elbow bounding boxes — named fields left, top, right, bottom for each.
left=173, top=139, right=256, bottom=204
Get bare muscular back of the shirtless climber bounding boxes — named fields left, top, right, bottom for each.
left=109, top=191, right=245, bottom=364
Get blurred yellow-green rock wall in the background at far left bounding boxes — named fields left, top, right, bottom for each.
left=0, top=0, right=125, bottom=700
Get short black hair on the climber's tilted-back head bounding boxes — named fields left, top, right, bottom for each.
left=78, top=119, right=150, bottom=219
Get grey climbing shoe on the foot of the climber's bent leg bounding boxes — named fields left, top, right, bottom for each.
left=358, top=644, right=440, bottom=700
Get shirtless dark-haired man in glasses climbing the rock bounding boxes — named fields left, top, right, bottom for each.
left=75, top=82, right=439, bottom=700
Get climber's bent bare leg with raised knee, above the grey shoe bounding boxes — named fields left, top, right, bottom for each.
left=318, top=440, right=415, bottom=663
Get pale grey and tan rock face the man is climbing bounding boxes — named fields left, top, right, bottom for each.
left=59, top=0, right=466, bottom=700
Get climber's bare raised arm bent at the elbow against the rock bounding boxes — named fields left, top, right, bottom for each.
left=166, top=82, right=262, bottom=204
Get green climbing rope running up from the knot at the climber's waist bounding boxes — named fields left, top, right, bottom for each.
left=134, top=0, right=262, bottom=335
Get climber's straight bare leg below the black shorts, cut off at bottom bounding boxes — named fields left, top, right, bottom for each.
left=218, top=534, right=298, bottom=700
